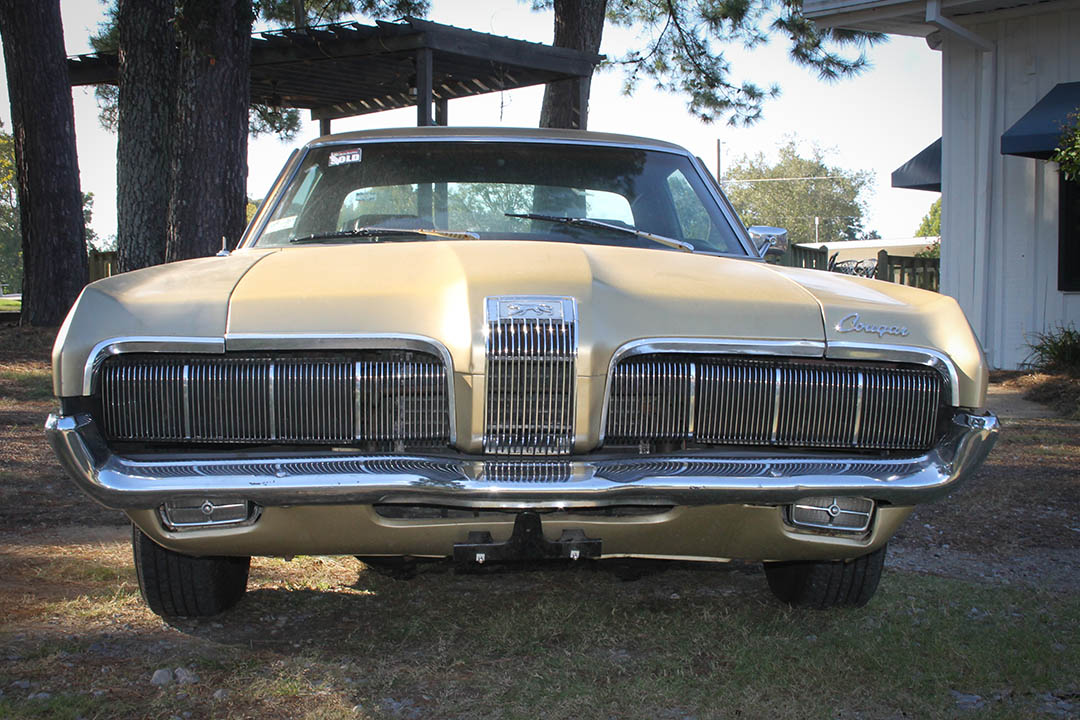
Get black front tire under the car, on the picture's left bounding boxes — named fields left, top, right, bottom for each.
left=132, top=526, right=252, bottom=617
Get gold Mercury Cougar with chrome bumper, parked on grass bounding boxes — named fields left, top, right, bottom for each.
left=46, top=127, right=998, bottom=616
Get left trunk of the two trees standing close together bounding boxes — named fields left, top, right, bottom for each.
left=117, top=0, right=176, bottom=272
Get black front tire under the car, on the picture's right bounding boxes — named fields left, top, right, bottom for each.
left=765, top=545, right=887, bottom=610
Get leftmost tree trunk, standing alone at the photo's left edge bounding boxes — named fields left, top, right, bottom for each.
left=0, top=0, right=87, bottom=326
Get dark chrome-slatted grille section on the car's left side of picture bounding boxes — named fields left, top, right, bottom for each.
left=100, top=351, right=450, bottom=445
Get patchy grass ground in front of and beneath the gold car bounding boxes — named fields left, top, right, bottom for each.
left=0, top=540, right=1080, bottom=719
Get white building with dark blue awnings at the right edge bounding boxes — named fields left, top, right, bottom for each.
left=804, top=0, right=1080, bottom=368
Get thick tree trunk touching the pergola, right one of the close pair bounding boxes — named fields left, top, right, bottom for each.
left=165, top=0, right=252, bottom=261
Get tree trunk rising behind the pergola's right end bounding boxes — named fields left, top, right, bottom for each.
left=540, top=0, right=607, bottom=130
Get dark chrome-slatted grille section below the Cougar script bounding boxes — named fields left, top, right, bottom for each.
left=606, top=355, right=945, bottom=450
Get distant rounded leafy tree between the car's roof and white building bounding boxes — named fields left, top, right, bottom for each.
left=724, top=138, right=873, bottom=243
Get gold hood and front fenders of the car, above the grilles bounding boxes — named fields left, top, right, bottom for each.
left=54, top=241, right=986, bottom=407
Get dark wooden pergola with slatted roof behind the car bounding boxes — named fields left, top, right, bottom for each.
left=68, top=17, right=604, bottom=135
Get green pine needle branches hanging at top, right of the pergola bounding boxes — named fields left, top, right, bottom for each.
left=532, top=0, right=886, bottom=126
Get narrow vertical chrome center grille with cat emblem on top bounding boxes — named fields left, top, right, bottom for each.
left=484, top=297, right=578, bottom=454
